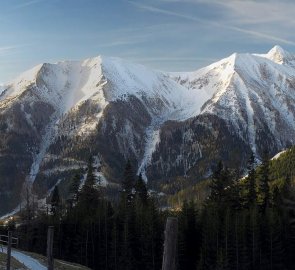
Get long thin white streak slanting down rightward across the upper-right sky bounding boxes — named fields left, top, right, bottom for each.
left=128, top=0, right=295, bottom=45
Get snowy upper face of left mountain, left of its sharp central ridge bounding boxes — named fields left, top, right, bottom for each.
left=1, top=57, right=106, bottom=113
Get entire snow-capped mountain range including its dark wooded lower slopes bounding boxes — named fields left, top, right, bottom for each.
left=0, top=46, right=295, bottom=212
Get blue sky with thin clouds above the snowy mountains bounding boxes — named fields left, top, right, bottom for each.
left=0, top=0, right=295, bottom=83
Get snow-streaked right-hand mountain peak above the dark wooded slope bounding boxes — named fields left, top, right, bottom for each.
left=171, top=46, right=295, bottom=153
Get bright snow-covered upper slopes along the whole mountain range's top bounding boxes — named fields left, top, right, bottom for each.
left=1, top=46, right=295, bottom=126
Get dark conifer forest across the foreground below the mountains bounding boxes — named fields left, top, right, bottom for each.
left=1, top=148, right=295, bottom=270
